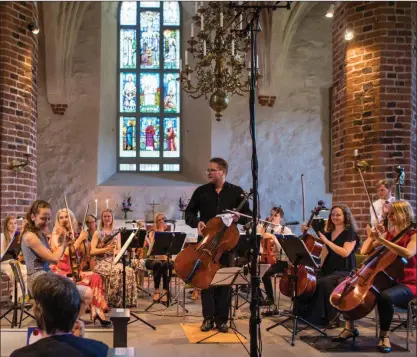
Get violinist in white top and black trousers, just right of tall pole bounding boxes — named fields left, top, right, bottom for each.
left=258, top=206, right=293, bottom=305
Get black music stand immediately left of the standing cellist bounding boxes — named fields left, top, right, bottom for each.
left=145, top=232, right=188, bottom=312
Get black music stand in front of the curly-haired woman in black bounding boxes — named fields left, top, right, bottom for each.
left=266, top=234, right=327, bottom=346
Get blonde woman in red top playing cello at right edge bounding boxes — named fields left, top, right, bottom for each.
left=333, top=200, right=417, bottom=353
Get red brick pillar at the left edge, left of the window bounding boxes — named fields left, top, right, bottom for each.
left=0, top=1, right=38, bottom=229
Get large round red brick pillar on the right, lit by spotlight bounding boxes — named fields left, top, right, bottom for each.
left=332, top=2, right=417, bottom=236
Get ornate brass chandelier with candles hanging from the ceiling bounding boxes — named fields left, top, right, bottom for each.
left=178, top=1, right=261, bottom=121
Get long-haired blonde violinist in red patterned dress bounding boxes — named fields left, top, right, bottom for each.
left=51, top=208, right=111, bottom=326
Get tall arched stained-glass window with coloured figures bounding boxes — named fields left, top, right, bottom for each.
left=117, top=1, right=182, bottom=172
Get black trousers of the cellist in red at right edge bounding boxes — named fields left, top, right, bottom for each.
left=377, top=284, right=414, bottom=331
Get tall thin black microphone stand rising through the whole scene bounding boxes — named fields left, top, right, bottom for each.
left=231, top=1, right=291, bottom=357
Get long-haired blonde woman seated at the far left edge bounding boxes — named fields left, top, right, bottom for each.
left=1, top=216, right=27, bottom=299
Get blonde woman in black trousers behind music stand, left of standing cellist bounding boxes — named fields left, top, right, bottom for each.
left=140, top=213, right=173, bottom=303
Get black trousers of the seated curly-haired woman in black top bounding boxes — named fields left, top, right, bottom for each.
left=298, top=271, right=349, bottom=326
